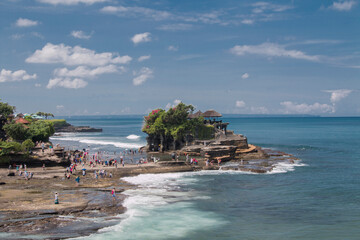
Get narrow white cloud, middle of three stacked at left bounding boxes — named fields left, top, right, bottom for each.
left=54, top=65, right=119, bottom=78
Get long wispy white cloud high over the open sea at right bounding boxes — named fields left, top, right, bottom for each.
left=230, top=42, right=320, bottom=61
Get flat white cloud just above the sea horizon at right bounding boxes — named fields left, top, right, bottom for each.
left=280, top=101, right=334, bottom=114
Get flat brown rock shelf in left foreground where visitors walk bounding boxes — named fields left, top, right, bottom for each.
left=0, top=163, right=194, bottom=239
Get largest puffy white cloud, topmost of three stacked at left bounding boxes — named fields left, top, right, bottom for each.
left=26, top=43, right=132, bottom=66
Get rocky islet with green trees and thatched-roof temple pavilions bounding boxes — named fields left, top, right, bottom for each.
left=143, top=103, right=260, bottom=164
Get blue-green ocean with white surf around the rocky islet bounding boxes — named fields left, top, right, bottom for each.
left=51, top=116, right=360, bottom=240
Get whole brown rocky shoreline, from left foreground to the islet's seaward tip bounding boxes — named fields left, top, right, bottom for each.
left=0, top=142, right=298, bottom=239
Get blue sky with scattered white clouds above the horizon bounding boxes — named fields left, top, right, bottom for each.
left=0, top=0, right=360, bottom=116
